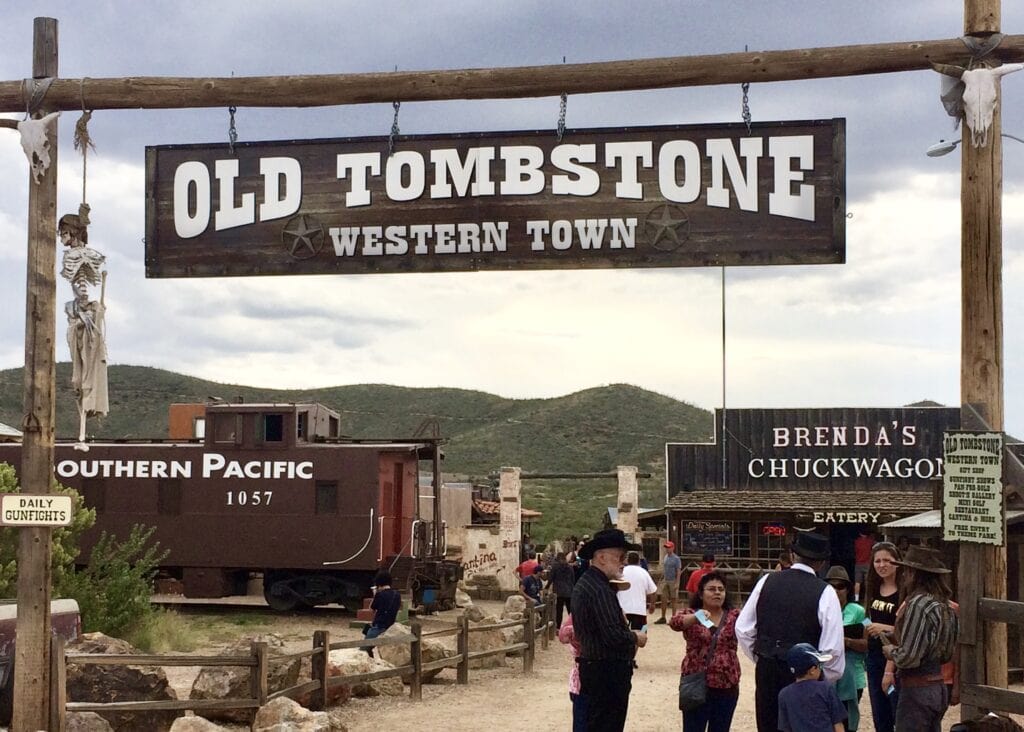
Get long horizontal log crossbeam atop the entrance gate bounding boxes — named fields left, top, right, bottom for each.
left=0, top=36, right=1024, bottom=113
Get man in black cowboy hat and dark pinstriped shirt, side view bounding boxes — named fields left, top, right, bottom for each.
left=571, top=528, right=647, bottom=732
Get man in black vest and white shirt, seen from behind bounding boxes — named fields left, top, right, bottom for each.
left=736, top=531, right=846, bottom=732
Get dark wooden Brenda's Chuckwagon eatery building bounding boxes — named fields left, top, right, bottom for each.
left=663, top=406, right=959, bottom=576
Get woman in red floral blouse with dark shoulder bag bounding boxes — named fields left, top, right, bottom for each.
left=669, top=571, right=739, bottom=732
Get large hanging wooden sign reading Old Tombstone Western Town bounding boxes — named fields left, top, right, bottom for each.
left=145, top=119, right=846, bottom=277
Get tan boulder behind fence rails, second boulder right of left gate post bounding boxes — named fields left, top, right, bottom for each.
left=188, top=633, right=299, bottom=724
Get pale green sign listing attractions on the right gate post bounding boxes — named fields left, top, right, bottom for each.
left=942, top=432, right=1005, bottom=547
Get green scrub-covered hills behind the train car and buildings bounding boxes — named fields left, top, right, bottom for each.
left=0, top=363, right=714, bottom=541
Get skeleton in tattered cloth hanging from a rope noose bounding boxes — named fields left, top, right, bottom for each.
left=57, top=104, right=110, bottom=449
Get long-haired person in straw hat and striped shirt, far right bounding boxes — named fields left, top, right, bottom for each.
left=882, top=546, right=959, bottom=732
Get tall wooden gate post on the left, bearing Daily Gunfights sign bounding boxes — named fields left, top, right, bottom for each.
left=11, top=17, right=57, bottom=732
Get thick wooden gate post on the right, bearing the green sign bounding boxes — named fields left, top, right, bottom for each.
left=959, top=0, right=1007, bottom=719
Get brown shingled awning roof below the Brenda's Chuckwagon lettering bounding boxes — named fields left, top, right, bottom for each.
left=669, top=490, right=932, bottom=514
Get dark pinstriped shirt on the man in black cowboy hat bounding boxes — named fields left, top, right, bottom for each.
left=571, top=567, right=637, bottom=660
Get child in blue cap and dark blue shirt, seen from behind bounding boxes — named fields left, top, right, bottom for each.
left=778, top=643, right=846, bottom=732
